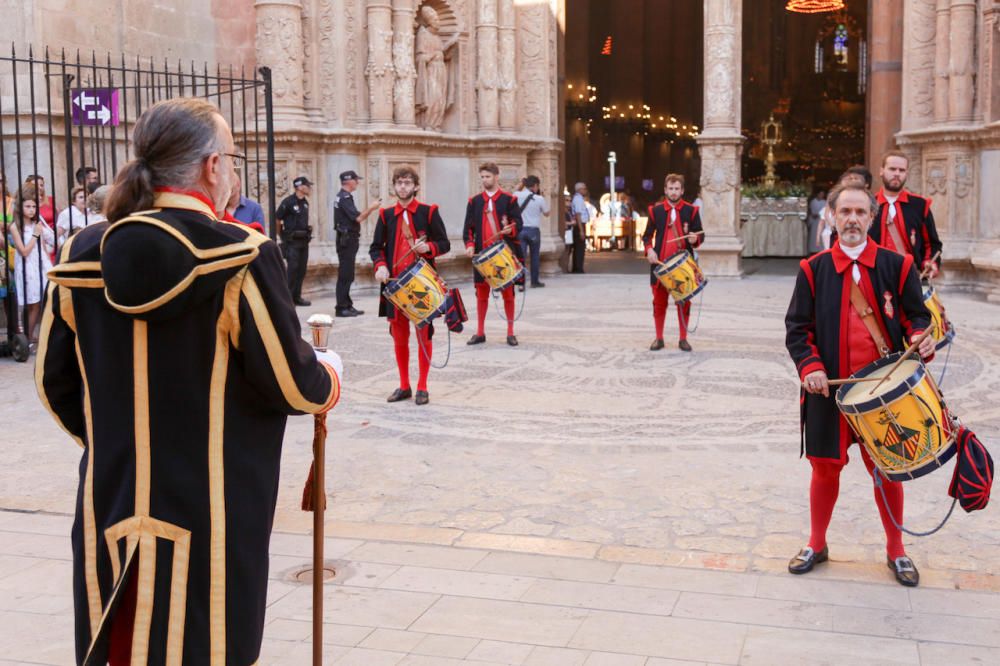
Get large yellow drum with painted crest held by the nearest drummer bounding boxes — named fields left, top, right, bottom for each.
left=837, top=352, right=956, bottom=481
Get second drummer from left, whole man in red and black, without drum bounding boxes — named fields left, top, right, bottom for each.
left=462, top=162, right=524, bottom=347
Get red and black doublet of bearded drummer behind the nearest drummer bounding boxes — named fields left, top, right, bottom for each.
left=868, top=188, right=942, bottom=269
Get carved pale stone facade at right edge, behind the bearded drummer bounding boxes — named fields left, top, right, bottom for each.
left=896, top=0, right=1000, bottom=300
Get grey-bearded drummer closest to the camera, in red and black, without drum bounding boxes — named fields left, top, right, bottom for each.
left=785, top=184, right=934, bottom=586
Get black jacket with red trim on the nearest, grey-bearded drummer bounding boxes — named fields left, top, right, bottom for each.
left=785, top=243, right=930, bottom=461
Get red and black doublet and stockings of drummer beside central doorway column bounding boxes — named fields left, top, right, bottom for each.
left=642, top=199, right=705, bottom=340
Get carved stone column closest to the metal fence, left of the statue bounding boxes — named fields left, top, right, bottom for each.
left=254, top=0, right=305, bottom=121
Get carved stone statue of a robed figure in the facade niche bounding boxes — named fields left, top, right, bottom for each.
left=414, top=5, right=458, bottom=131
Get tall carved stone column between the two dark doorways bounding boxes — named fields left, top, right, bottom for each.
left=698, top=0, right=743, bottom=276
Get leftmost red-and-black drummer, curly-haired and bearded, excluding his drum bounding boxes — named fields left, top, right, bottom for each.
left=369, top=165, right=451, bottom=405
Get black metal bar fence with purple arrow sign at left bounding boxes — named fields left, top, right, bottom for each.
left=0, top=46, right=275, bottom=358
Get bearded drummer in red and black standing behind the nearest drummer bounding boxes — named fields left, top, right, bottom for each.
left=869, top=150, right=942, bottom=277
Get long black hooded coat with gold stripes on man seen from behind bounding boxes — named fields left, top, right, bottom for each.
left=35, top=192, right=340, bottom=664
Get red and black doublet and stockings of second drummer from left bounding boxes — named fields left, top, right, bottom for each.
left=462, top=190, right=524, bottom=335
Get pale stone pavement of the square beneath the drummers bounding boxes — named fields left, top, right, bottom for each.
left=0, top=254, right=1000, bottom=665
